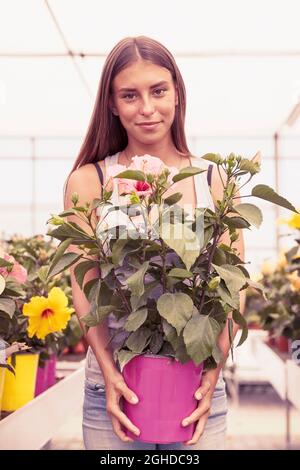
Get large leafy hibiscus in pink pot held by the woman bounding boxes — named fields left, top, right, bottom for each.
left=47, top=154, right=296, bottom=442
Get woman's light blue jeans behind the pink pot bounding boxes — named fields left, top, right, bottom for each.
left=82, top=348, right=227, bottom=451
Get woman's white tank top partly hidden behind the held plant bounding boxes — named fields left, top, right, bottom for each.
left=96, top=152, right=215, bottom=329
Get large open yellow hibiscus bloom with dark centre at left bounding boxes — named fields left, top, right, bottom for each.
left=23, top=287, right=74, bottom=339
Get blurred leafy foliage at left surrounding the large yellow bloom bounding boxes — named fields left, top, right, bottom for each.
left=0, top=235, right=82, bottom=366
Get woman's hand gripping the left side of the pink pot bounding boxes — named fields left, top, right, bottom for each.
left=106, top=374, right=140, bottom=442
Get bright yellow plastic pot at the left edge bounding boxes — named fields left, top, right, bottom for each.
left=1, top=353, right=39, bottom=411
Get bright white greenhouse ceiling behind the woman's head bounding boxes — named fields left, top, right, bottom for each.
left=0, top=0, right=300, bottom=137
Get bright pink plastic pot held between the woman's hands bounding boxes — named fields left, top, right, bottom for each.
left=123, top=355, right=203, bottom=444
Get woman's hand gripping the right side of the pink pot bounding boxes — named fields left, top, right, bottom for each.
left=182, top=373, right=214, bottom=445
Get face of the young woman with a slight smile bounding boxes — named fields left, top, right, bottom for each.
left=110, top=60, right=178, bottom=143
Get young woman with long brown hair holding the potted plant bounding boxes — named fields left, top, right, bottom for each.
left=64, top=36, right=244, bottom=450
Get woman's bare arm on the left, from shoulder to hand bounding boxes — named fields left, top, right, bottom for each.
left=64, top=164, right=140, bottom=442
